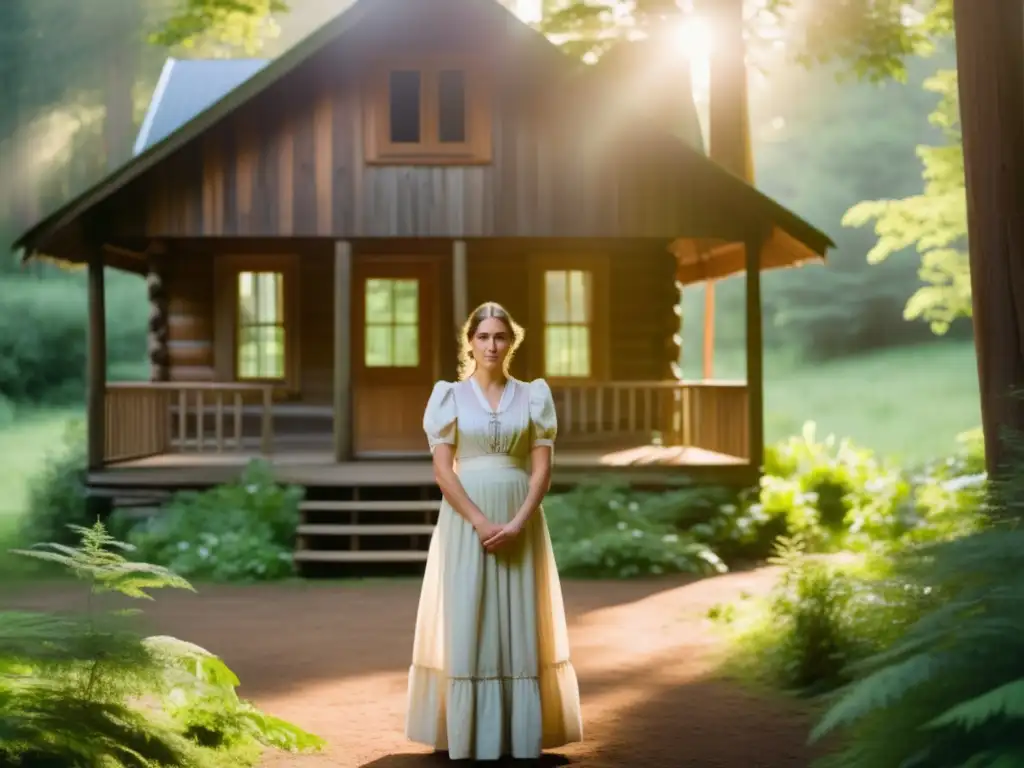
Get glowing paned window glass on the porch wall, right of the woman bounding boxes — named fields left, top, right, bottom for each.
left=544, top=269, right=594, bottom=378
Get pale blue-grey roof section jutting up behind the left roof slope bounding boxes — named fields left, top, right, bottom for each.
left=133, top=58, right=269, bottom=155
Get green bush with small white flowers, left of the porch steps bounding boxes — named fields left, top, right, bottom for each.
left=128, top=461, right=303, bottom=582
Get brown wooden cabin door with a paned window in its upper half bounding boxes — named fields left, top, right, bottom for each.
left=352, top=256, right=437, bottom=457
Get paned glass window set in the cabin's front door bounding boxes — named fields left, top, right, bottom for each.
left=364, top=278, right=420, bottom=368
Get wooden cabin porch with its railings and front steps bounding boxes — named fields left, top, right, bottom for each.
left=96, top=381, right=757, bottom=572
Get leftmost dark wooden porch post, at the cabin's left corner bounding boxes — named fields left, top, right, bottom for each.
left=86, top=247, right=106, bottom=470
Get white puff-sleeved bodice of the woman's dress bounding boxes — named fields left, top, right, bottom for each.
left=423, top=378, right=558, bottom=461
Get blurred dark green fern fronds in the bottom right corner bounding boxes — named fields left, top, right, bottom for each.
left=813, top=444, right=1024, bottom=768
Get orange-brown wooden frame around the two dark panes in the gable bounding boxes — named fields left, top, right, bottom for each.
left=364, top=56, right=494, bottom=165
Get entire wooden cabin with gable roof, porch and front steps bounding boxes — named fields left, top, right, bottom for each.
left=15, top=0, right=831, bottom=561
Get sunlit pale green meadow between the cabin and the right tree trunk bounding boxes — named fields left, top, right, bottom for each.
left=716, top=342, right=981, bottom=463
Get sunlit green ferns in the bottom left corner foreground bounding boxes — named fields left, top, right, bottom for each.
left=0, top=522, right=323, bottom=768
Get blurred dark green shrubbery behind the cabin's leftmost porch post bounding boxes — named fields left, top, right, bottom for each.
left=0, top=270, right=150, bottom=402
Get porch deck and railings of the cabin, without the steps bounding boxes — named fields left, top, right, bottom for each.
left=101, top=381, right=750, bottom=486
